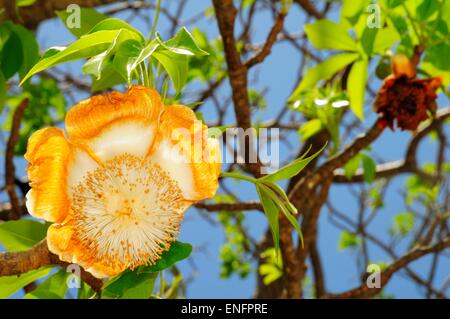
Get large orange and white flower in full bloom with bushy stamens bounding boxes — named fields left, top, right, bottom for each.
left=25, top=87, right=220, bottom=278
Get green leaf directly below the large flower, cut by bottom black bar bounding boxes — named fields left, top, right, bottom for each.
left=102, top=270, right=158, bottom=299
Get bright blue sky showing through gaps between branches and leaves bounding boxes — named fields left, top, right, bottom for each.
left=0, top=0, right=450, bottom=298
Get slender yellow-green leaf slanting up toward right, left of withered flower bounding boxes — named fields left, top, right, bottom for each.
left=289, top=53, right=359, bottom=101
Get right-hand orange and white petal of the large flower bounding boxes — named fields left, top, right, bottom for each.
left=149, top=105, right=221, bottom=200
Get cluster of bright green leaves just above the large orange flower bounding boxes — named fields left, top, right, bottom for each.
left=22, top=9, right=208, bottom=96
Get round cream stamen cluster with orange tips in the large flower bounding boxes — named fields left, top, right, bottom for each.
left=72, top=154, right=189, bottom=269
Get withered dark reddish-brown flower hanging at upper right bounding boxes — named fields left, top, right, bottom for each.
left=375, top=55, right=442, bottom=131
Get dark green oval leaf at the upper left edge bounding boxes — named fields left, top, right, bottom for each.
left=0, top=32, right=24, bottom=79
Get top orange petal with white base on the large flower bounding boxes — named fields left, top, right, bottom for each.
left=66, top=86, right=162, bottom=160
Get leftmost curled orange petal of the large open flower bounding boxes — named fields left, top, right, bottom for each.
left=25, top=127, right=71, bottom=222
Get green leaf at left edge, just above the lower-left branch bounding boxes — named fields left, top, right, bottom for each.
left=0, top=219, right=48, bottom=251
